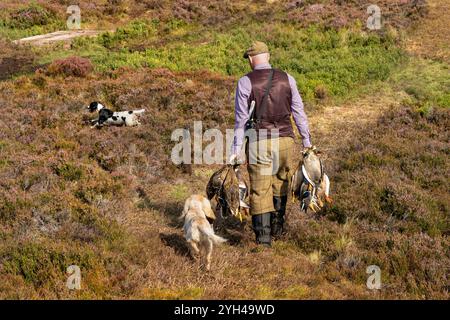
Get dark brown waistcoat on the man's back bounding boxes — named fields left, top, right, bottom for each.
left=247, top=69, right=294, bottom=137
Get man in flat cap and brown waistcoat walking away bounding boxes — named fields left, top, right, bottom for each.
left=229, top=41, right=311, bottom=246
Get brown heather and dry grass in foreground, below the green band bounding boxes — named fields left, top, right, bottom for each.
left=0, top=61, right=448, bottom=299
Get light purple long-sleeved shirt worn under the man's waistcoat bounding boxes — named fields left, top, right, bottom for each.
left=231, top=63, right=311, bottom=154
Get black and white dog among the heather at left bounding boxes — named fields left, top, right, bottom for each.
left=87, top=101, right=145, bottom=128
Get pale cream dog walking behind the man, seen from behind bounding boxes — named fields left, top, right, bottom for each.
left=180, top=195, right=227, bottom=270
